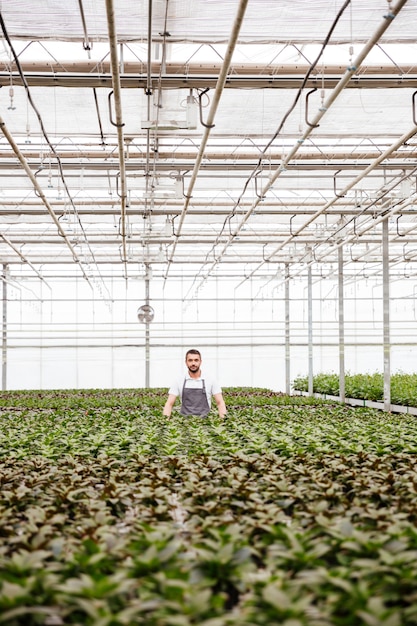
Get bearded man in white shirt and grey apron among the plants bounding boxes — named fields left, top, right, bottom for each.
left=163, top=350, right=226, bottom=417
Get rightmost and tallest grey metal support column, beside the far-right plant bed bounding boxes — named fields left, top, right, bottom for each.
left=382, top=219, right=391, bottom=411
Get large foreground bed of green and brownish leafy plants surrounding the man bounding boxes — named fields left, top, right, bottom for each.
left=0, top=390, right=417, bottom=626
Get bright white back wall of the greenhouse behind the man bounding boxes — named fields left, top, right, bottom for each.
left=7, top=270, right=417, bottom=391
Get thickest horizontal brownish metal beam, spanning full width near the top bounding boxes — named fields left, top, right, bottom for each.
left=0, top=62, right=416, bottom=90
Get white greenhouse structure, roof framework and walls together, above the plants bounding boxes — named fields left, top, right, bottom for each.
left=0, top=0, right=417, bottom=404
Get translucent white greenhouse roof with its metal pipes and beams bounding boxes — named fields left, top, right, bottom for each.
left=0, top=0, right=417, bottom=287
